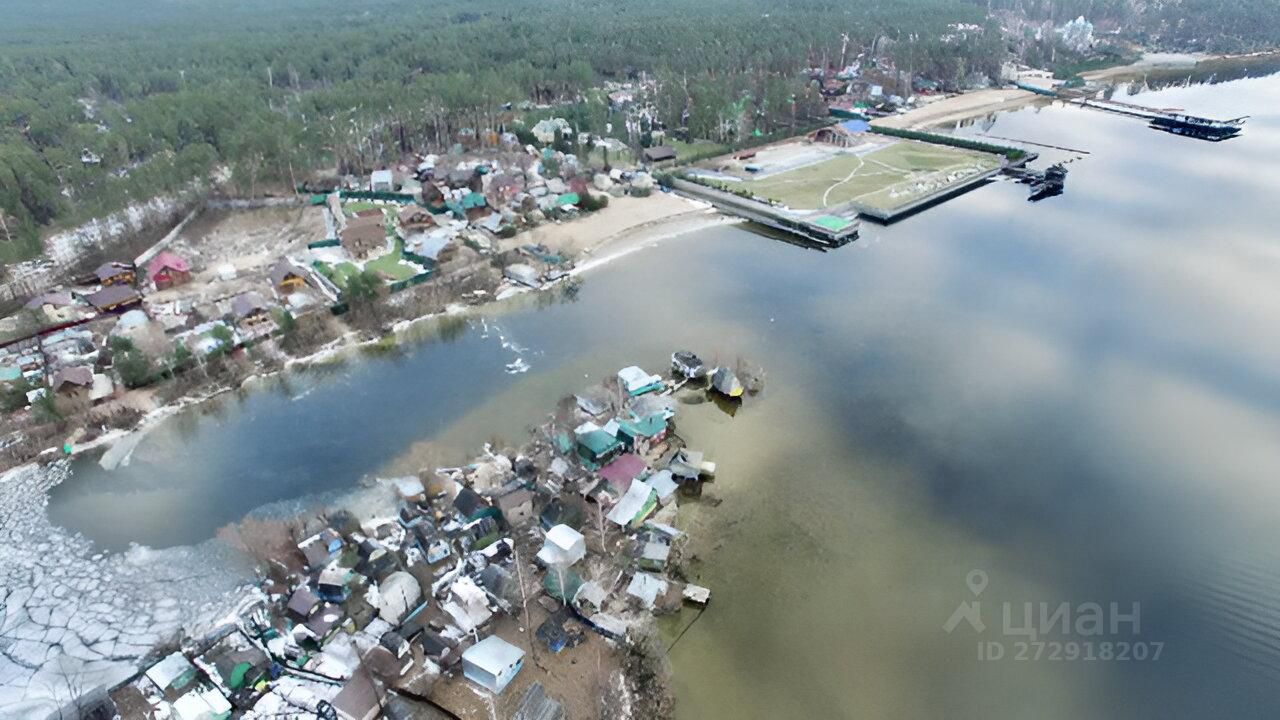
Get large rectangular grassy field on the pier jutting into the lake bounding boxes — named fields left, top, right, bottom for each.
left=739, top=141, right=1000, bottom=210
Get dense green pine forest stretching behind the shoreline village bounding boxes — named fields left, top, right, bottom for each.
left=0, top=0, right=1280, bottom=261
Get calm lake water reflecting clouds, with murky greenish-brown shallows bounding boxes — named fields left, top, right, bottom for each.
left=42, top=70, right=1280, bottom=719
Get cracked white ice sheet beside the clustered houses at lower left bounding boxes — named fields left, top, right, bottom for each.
left=0, top=462, right=252, bottom=720
